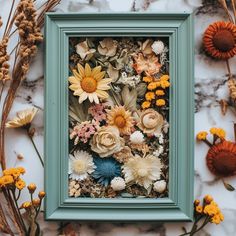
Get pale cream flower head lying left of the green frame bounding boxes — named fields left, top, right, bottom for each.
left=6, top=107, right=38, bottom=128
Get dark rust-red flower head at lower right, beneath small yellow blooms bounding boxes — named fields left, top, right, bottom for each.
left=206, top=140, right=236, bottom=177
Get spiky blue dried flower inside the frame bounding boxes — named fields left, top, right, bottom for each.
left=92, top=157, right=121, bottom=186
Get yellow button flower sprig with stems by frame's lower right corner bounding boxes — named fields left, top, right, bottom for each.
left=179, top=195, right=224, bottom=236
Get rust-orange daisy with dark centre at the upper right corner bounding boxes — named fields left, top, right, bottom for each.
left=203, top=21, right=236, bottom=60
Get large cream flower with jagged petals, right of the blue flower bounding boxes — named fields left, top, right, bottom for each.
left=122, top=155, right=163, bottom=189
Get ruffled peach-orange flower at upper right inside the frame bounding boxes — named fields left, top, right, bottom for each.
left=133, top=53, right=161, bottom=76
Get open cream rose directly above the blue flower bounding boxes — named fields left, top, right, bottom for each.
left=90, top=126, right=125, bottom=157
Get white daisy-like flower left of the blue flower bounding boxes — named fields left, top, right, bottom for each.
left=68, top=151, right=96, bottom=180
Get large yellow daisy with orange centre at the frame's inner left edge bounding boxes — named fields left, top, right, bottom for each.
left=69, top=63, right=112, bottom=104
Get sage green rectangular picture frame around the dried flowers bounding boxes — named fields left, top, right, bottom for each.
left=45, top=13, right=194, bottom=221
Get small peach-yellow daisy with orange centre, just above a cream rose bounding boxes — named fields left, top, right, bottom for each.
left=107, top=106, right=133, bottom=134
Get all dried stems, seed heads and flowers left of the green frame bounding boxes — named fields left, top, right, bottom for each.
left=0, top=0, right=60, bottom=235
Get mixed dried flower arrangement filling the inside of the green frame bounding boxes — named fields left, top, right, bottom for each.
left=68, top=37, right=170, bottom=198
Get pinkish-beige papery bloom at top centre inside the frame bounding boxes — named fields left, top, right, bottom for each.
left=98, top=38, right=118, bottom=57
